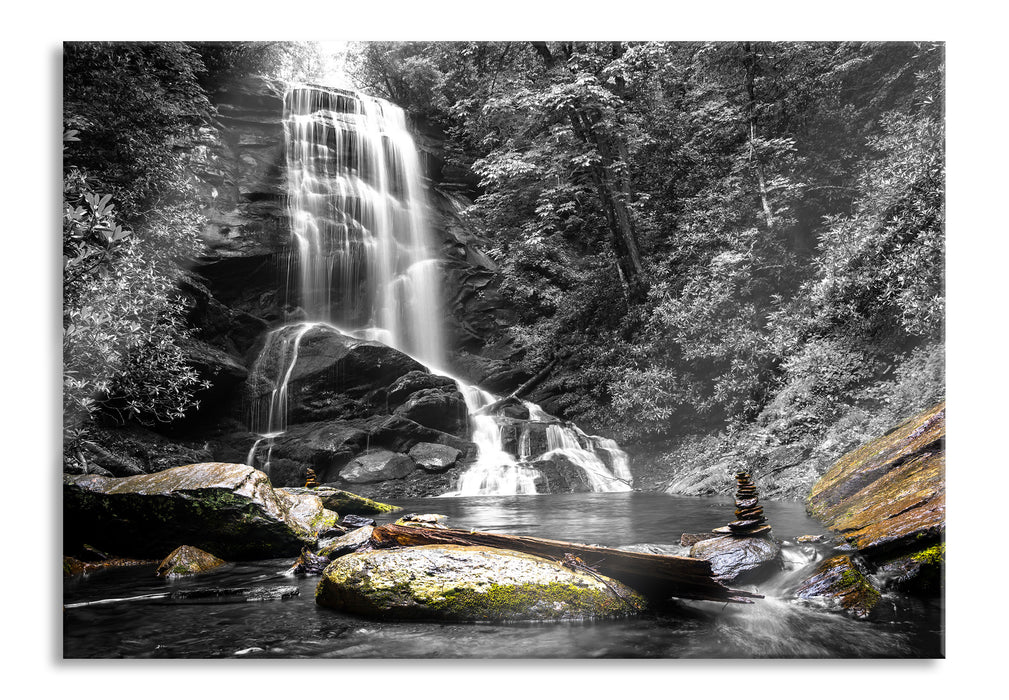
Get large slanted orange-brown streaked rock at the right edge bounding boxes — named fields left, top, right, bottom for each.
left=806, top=403, right=945, bottom=559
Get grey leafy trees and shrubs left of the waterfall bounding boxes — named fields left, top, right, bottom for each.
left=63, top=42, right=314, bottom=453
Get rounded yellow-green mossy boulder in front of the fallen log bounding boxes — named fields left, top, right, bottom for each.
left=316, top=546, right=646, bottom=621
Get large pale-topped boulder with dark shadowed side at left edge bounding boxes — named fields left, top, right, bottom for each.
left=64, top=462, right=336, bottom=561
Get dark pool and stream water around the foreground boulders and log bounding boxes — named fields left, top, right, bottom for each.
left=64, top=492, right=943, bottom=659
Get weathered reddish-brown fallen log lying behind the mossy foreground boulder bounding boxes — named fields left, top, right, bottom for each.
left=371, top=524, right=764, bottom=603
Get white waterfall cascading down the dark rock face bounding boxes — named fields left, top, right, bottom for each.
left=247, top=86, right=632, bottom=495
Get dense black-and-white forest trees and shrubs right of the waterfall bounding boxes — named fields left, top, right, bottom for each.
left=353, top=42, right=944, bottom=447
